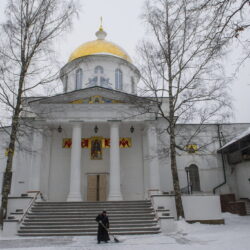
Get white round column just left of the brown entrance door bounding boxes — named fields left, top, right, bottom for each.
left=67, top=122, right=82, bottom=201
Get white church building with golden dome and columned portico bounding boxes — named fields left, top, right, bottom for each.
left=0, top=27, right=250, bottom=233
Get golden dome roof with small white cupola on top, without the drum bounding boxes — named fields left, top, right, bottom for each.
left=69, top=26, right=132, bottom=63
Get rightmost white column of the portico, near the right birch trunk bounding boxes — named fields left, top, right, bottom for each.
left=147, top=121, right=160, bottom=193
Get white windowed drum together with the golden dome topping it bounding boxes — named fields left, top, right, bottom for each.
left=60, top=26, right=140, bottom=94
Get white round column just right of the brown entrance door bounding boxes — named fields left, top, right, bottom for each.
left=108, top=121, right=123, bottom=201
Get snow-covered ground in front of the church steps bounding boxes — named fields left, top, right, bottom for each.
left=0, top=213, right=250, bottom=250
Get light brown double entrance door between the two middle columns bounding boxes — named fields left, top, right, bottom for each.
left=87, top=174, right=107, bottom=201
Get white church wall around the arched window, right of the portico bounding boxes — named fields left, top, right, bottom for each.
left=158, top=123, right=249, bottom=195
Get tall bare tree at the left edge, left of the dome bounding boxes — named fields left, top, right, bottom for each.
left=0, top=0, right=77, bottom=227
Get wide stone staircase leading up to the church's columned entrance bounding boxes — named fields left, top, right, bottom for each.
left=18, top=201, right=160, bottom=236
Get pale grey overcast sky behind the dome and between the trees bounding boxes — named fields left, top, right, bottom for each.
left=0, top=0, right=250, bottom=122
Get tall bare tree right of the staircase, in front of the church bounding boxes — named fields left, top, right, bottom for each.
left=138, top=0, right=230, bottom=218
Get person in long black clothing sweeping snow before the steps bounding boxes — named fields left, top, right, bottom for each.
left=95, top=211, right=110, bottom=244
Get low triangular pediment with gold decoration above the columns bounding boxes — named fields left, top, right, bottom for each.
left=30, top=87, right=154, bottom=104
